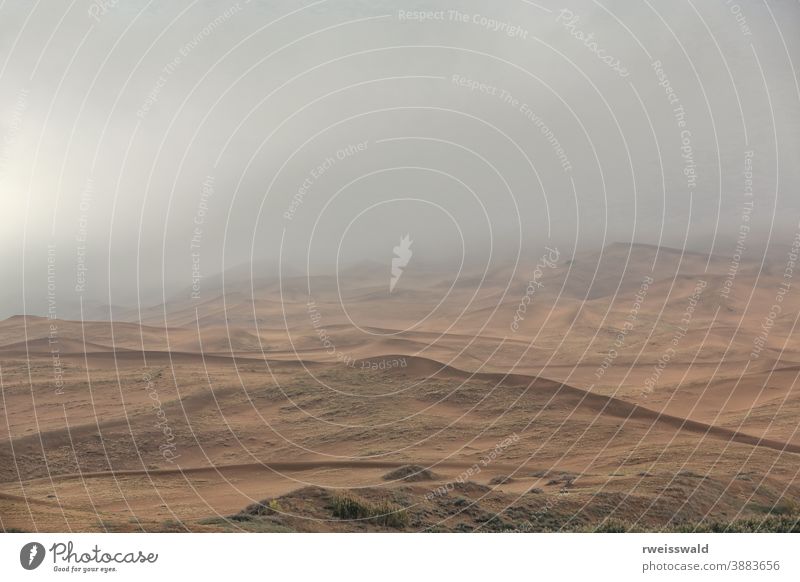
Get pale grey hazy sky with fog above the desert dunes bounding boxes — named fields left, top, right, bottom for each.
left=0, top=0, right=800, bottom=317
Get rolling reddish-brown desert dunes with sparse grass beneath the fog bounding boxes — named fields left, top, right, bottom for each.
left=0, top=244, right=800, bottom=531
